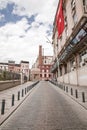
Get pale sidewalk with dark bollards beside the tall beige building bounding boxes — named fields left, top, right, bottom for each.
left=50, top=81, right=87, bottom=109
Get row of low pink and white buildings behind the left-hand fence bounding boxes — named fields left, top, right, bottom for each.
left=0, top=61, right=30, bottom=83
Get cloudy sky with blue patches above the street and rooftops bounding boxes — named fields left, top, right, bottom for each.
left=0, top=0, right=59, bottom=67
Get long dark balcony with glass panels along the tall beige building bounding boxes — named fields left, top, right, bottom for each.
left=59, top=21, right=87, bottom=63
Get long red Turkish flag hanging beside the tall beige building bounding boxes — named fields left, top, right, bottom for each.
left=56, top=0, right=64, bottom=38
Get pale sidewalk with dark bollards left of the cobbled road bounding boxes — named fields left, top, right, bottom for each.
left=0, top=82, right=37, bottom=125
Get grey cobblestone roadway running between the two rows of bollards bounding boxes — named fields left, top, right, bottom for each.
left=0, top=81, right=87, bottom=130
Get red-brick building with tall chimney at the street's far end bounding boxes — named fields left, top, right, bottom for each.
left=31, top=45, right=53, bottom=80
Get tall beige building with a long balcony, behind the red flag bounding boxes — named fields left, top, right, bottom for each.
left=51, top=0, right=87, bottom=86
